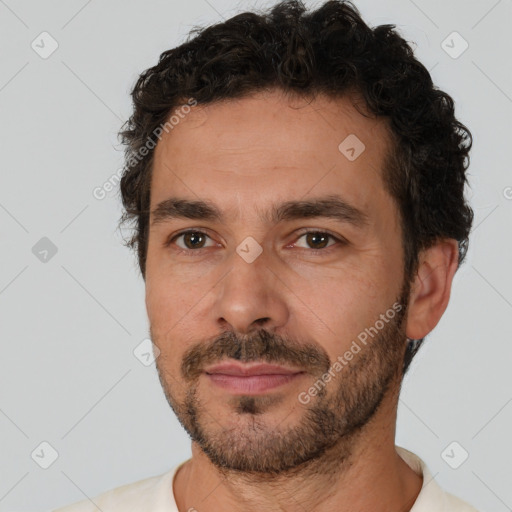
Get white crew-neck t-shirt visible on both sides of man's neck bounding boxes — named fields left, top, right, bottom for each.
left=54, top=446, right=478, bottom=512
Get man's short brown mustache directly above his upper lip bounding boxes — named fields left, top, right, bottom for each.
left=181, top=329, right=331, bottom=381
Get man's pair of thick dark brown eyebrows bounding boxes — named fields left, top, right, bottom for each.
left=151, top=195, right=369, bottom=227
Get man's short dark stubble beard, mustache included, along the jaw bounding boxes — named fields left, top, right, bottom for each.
left=157, top=285, right=409, bottom=477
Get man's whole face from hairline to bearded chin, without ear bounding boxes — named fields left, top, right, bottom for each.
left=146, top=92, right=409, bottom=472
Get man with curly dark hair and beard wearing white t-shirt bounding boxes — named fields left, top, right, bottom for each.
left=55, top=0, right=475, bottom=512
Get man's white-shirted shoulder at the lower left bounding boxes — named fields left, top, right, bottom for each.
left=53, top=468, right=177, bottom=512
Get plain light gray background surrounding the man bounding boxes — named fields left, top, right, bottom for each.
left=0, top=0, right=512, bottom=512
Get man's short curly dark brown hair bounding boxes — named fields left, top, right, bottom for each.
left=119, top=0, right=473, bottom=372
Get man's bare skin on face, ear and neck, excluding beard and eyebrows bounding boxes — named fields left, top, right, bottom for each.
left=146, top=91, right=458, bottom=512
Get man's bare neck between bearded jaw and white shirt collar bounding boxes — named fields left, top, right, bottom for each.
left=174, top=380, right=422, bottom=512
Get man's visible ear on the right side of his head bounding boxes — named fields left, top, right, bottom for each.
left=406, top=238, right=459, bottom=340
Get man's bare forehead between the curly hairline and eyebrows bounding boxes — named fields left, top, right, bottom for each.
left=151, top=91, right=390, bottom=224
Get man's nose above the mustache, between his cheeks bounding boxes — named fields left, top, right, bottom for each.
left=213, top=245, right=289, bottom=334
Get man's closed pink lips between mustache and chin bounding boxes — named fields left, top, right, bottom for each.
left=204, top=362, right=305, bottom=395
